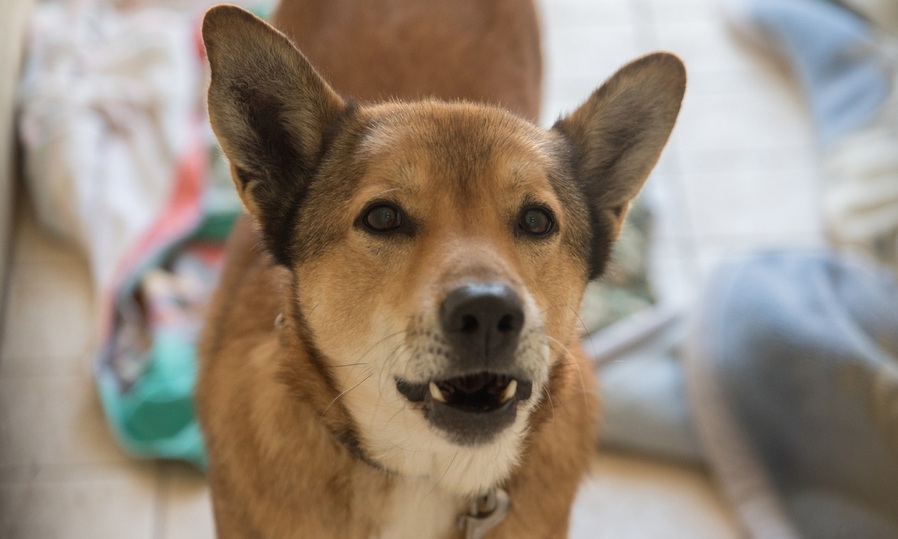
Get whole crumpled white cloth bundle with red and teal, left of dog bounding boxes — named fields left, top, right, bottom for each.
left=19, top=1, right=241, bottom=468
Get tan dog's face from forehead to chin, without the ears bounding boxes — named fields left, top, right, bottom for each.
left=292, top=103, right=588, bottom=490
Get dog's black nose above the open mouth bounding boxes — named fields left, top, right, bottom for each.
left=440, top=283, right=524, bottom=369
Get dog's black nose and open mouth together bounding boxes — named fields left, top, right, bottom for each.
left=396, top=283, right=533, bottom=445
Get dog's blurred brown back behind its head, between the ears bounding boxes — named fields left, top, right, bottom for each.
left=273, top=0, right=542, bottom=121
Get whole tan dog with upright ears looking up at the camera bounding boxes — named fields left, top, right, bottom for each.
left=197, top=0, right=686, bottom=538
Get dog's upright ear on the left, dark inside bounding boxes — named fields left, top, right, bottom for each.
left=203, top=6, right=345, bottom=265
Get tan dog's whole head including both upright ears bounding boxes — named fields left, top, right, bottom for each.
left=203, top=7, right=685, bottom=500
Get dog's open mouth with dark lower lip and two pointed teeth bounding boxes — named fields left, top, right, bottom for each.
left=396, top=372, right=533, bottom=447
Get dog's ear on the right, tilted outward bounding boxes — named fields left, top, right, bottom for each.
left=553, top=53, right=686, bottom=278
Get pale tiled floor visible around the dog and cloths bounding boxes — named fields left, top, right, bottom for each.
left=0, top=0, right=822, bottom=539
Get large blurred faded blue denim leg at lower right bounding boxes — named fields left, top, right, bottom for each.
left=686, top=253, right=898, bottom=539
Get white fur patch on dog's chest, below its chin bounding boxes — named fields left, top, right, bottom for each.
left=378, top=479, right=464, bottom=539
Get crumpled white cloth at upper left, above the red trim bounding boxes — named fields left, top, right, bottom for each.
left=19, top=2, right=202, bottom=294
